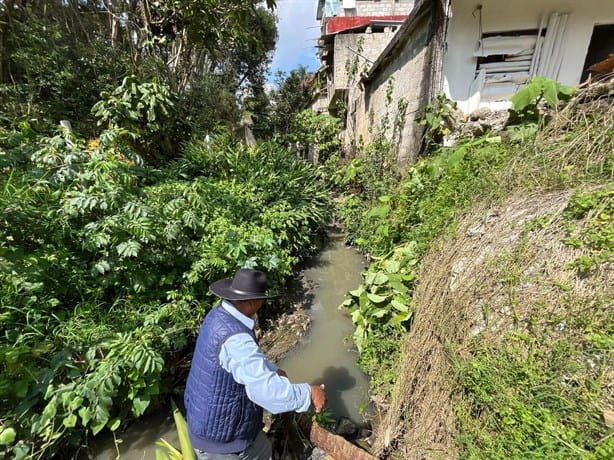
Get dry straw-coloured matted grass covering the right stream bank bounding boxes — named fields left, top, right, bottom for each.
left=376, top=191, right=613, bottom=459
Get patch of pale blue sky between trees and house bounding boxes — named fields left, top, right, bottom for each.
left=271, top=0, right=320, bottom=80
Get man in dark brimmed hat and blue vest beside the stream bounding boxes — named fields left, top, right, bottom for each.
left=185, top=269, right=326, bottom=460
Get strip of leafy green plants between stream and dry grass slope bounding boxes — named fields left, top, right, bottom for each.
left=342, top=132, right=513, bottom=395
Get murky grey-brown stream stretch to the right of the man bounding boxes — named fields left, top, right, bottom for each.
left=279, top=234, right=369, bottom=423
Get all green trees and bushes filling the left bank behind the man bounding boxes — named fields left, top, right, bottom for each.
left=0, top=0, right=346, bottom=459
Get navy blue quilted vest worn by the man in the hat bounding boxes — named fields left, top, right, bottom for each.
left=184, top=306, right=263, bottom=454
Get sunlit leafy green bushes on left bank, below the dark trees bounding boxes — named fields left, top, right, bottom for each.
left=0, top=115, right=330, bottom=458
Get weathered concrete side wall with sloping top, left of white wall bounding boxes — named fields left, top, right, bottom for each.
left=344, top=10, right=430, bottom=162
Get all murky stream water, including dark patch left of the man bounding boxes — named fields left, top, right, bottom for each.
left=94, top=234, right=369, bottom=460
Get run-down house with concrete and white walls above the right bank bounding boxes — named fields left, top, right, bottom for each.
left=318, top=0, right=614, bottom=161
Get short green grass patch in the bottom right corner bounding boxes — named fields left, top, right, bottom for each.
left=456, top=304, right=614, bottom=459
